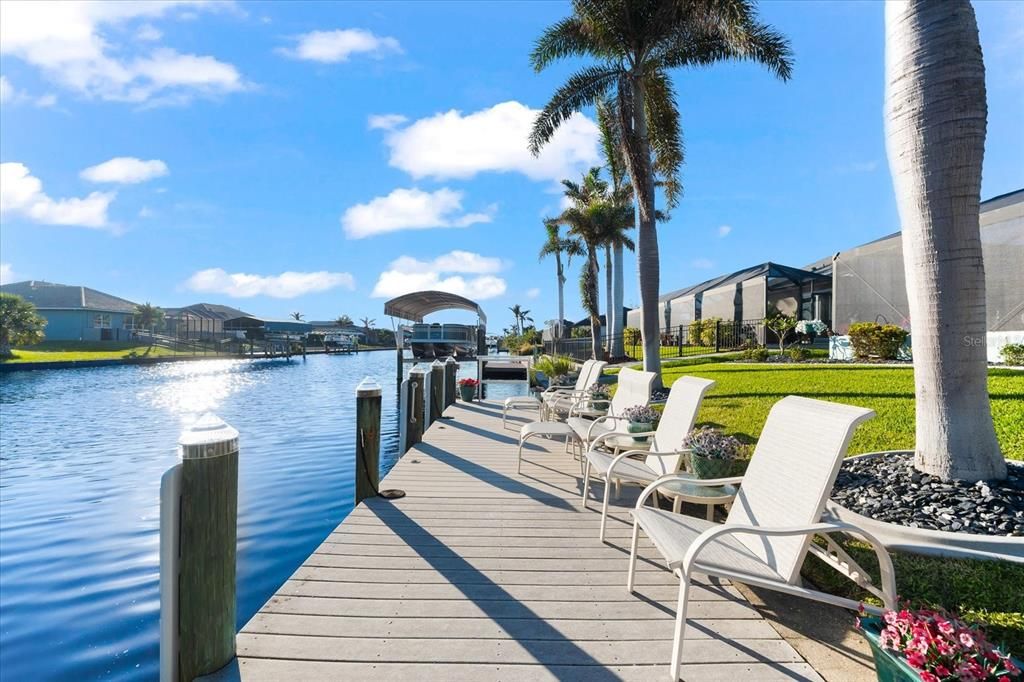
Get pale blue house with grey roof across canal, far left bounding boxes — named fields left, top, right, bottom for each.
left=0, top=281, right=136, bottom=341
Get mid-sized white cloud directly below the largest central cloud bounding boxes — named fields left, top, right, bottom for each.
left=341, top=187, right=496, bottom=240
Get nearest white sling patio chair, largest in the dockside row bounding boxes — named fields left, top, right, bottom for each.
left=627, top=395, right=896, bottom=680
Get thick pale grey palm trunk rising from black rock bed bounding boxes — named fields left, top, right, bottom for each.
left=886, top=0, right=1007, bottom=481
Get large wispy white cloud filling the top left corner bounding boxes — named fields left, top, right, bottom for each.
left=0, top=0, right=246, bottom=102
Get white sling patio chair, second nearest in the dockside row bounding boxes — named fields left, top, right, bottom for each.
left=582, top=377, right=715, bottom=542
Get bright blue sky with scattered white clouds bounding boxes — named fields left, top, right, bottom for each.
left=0, top=1, right=1024, bottom=329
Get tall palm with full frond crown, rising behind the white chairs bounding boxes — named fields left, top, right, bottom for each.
left=529, top=0, right=793, bottom=379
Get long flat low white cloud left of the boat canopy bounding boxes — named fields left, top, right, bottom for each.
left=184, top=267, right=355, bottom=298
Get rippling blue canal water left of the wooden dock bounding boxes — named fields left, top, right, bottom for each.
left=0, top=352, right=512, bottom=680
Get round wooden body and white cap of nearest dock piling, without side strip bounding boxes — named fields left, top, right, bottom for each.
left=178, top=414, right=239, bottom=681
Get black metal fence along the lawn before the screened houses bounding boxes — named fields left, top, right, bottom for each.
left=544, top=319, right=775, bottom=361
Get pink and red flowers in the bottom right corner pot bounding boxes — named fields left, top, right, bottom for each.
left=857, top=604, right=1021, bottom=682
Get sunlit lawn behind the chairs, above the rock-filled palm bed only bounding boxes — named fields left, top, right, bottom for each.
left=663, top=357, right=1024, bottom=460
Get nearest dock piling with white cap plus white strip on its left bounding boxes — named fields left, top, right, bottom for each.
left=172, top=414, right=239, bottom=682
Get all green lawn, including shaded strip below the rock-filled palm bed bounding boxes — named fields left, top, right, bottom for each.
left=647, top=356, right=1024, bottom=655
